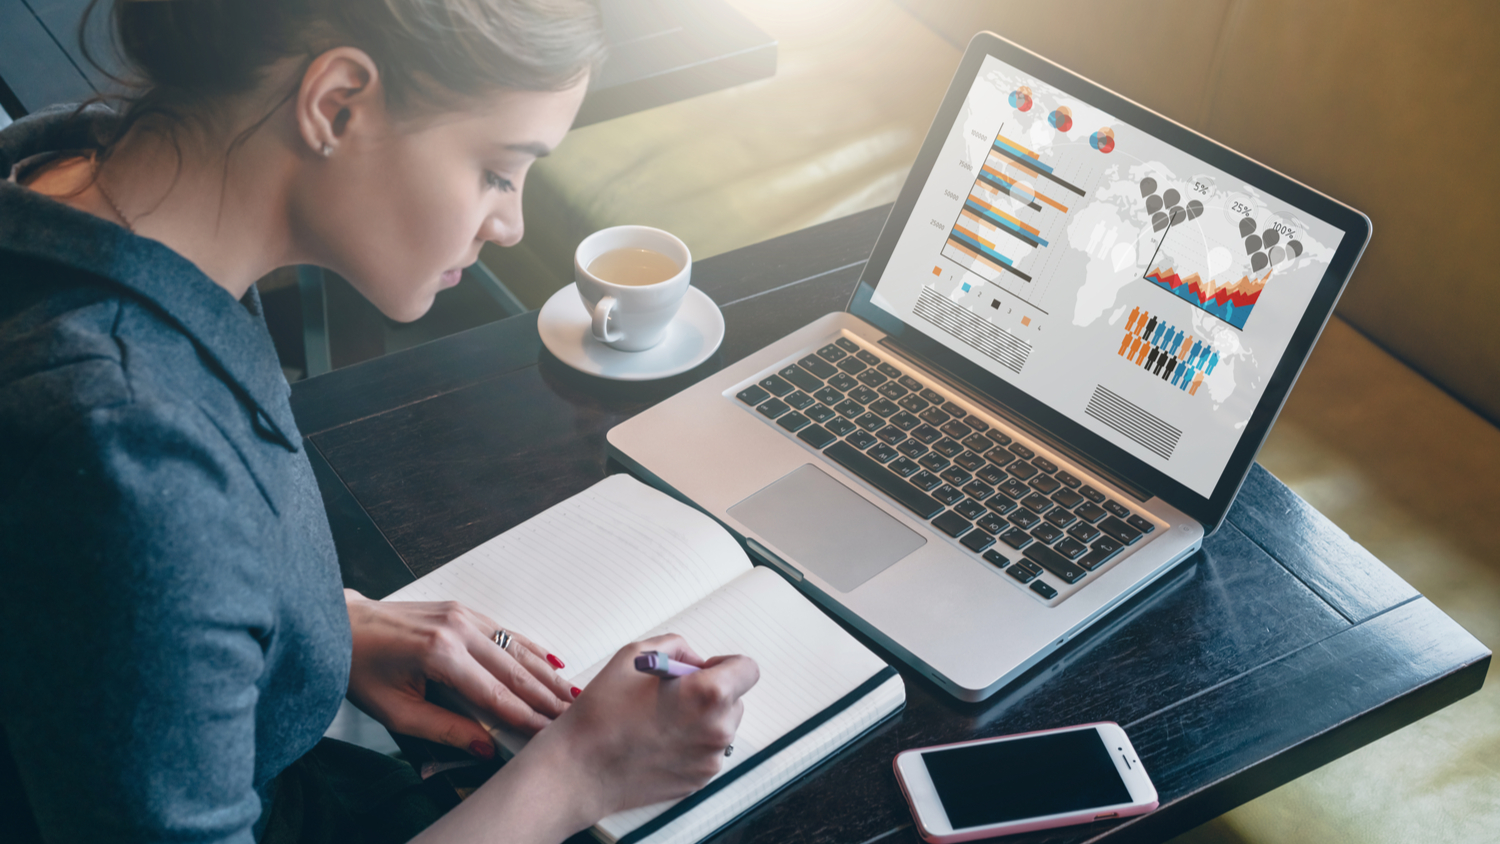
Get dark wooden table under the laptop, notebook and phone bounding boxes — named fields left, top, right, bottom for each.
left=293, top=208, right=1490, bottom=844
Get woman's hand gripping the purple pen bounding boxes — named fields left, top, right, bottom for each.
left=527, top=634, right=761, bottom=820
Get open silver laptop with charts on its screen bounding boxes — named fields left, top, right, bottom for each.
left=608, top=33, right=1371, bottom=700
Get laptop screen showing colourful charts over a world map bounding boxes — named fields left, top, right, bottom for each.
left=870, top=55, right=1344, bottom=498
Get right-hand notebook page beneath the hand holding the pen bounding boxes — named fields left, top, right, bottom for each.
left=575, top=567, right=885, bottom=838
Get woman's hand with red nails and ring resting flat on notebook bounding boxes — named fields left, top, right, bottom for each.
left=344, top=589, right=573, bottom=759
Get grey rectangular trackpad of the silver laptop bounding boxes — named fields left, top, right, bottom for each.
left=729, top=463, right=927, bottom=592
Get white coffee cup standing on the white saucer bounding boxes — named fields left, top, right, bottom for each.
left=573, top=226, right=693, bottom=352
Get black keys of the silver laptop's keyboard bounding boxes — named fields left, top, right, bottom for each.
left=737, top=337, right=1157, bottom=601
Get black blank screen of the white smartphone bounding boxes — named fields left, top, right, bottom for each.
left=923, top=729, right=1130, bottom=829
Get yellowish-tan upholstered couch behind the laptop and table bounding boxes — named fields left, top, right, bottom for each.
left=485, top=0, right=1500, bottom=844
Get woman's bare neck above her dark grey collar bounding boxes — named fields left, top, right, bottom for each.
left=27, top=107, right=299, bottom=298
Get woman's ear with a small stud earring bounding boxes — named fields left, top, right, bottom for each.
left=297, top=46, right=386, bottom=157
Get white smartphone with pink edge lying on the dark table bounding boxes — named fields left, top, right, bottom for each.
left=896, top=721, right=1157, bottom=844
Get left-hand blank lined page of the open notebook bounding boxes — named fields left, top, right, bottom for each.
left=386, top=475, right=750, bottom=685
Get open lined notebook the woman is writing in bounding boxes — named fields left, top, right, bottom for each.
left=386, top=475, right=906, bottom=844
